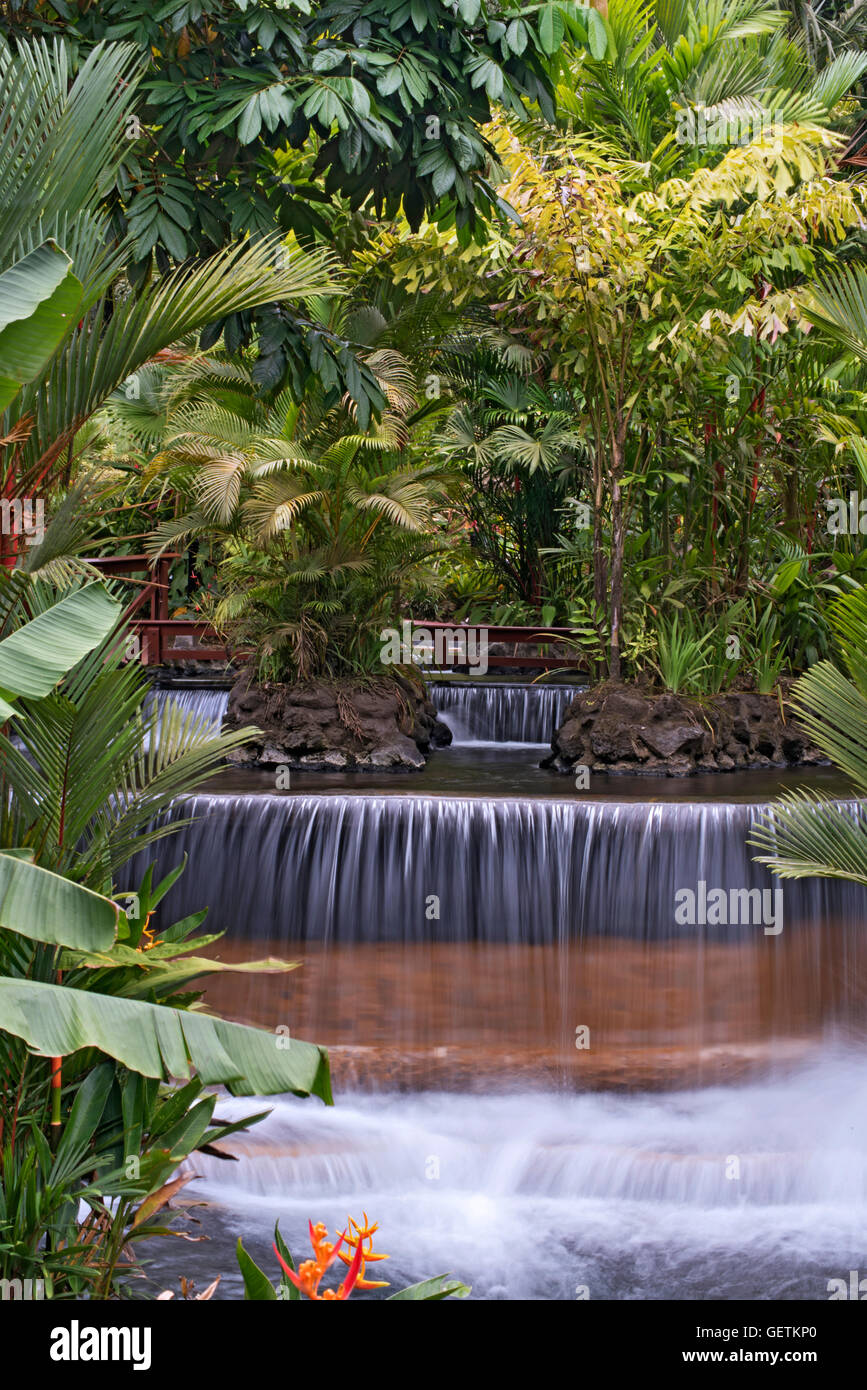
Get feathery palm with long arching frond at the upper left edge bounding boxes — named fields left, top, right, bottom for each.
left=0, top=31, right=339, bottom=550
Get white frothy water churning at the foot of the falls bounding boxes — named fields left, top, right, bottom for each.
left=187, top=1052, right=867, bottom=1300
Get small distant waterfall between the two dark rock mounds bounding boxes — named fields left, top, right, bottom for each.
left=429, top=681, right=585, bottom=745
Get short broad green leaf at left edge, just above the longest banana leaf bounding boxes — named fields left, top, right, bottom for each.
left=0, top=852, right=118, bottom=951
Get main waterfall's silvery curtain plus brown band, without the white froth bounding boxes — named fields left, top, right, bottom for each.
left=130, top=792, right=867, bottom=1094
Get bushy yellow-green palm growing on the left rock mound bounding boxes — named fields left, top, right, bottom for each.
left=119, top=349, right=456, bottom=680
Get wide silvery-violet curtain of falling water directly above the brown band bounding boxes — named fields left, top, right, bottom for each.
left=138, top=792, right=867, bottom=945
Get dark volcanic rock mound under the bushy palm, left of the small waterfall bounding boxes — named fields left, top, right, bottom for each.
left=225, top=671, right=452, bottom=771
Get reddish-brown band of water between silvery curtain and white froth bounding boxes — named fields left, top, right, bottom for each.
left=200, top=923, right=867, bottom=1093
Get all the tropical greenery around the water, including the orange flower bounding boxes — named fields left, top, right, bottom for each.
left=0, top=0, right=867, bottom=1301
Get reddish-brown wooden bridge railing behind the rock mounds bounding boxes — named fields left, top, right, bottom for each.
left=88, top=552, right=575, bottom=671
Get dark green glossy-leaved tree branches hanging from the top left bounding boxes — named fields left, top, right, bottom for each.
left=1, top=0, right=606, bottom=405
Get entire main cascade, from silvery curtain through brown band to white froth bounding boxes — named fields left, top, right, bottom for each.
left=142, top=688, right=867, bottom=1300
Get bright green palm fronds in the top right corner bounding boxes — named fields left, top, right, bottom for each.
left=557, top=0, right=867, bottom=186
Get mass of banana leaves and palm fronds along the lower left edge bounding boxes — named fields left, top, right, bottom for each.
left=0, top=574, right=331, bottom=1297
